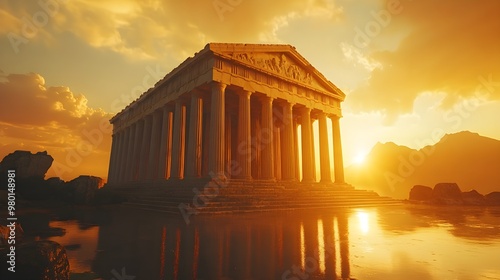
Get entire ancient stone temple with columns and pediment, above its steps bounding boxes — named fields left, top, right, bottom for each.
left=108, top=43, right=345, bottom=187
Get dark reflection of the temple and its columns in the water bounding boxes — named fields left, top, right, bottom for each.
left=92, top=209, right=356, bottom=279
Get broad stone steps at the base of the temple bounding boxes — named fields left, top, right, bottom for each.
left=114, top=183, right=401, bottom=214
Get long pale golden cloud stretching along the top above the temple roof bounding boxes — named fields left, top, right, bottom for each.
left=0, top=0, right=342, bottom=59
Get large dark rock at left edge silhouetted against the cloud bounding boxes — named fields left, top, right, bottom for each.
left=0, top=151, right=54, bottom=179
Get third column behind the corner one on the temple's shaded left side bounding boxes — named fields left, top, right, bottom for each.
left=157, top=106, right=173, bottom=179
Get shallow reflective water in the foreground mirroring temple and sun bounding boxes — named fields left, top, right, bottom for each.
left=12, top=205, right=500, bottom=280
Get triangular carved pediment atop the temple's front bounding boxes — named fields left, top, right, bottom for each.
left=207, top=43, right=345, bottom=99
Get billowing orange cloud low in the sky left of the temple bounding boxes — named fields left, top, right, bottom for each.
left=0, top=73, right=111, bottom=180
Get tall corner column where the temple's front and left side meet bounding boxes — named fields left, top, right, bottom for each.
left=208, top=82, right=226, bottom=179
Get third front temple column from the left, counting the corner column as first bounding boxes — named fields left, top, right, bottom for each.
left=261, top=96, right=275, bottom=180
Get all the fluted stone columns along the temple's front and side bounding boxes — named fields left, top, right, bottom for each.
left=108, top=82, right=344, bottom=183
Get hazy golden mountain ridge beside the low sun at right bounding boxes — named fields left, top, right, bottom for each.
left=346, top=131, right=500, bottom=198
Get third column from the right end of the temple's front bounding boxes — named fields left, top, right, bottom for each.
left=301, top=108, right=314, bottom=182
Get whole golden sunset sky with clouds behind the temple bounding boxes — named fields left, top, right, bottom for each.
left=0, top=0, right=500, bottom=180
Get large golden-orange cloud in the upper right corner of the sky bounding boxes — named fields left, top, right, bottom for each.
left=349, top=0, right=500, bottom=122
